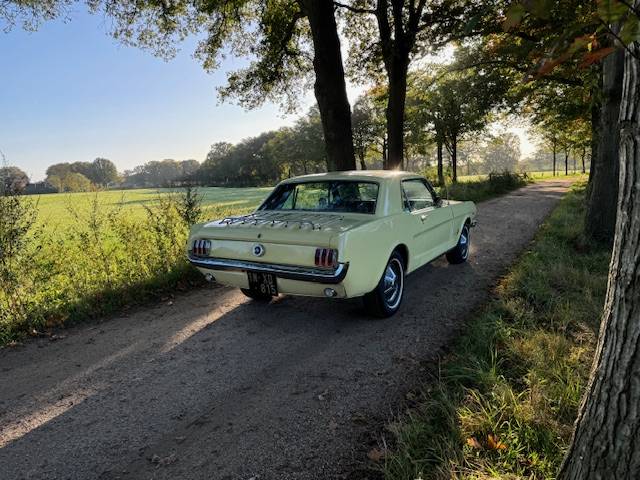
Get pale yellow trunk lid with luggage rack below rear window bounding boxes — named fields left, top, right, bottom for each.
left=192, top=211, right=374, bottom=245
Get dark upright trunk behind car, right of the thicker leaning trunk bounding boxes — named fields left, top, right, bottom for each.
left=386, top=57, right=408, bottom=170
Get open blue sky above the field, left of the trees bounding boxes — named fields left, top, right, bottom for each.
left=0, top=10, right=312, bottom=180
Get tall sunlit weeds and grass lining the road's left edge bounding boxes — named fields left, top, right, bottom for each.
left=0, top=190, right=247, bottom=345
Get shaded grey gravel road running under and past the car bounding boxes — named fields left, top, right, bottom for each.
left=0, top=181, right=569, bottom=480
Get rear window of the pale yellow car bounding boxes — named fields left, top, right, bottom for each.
left=260, top=180, right=378, bottom=214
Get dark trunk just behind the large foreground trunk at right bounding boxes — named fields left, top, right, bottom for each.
left=585, top=50, right=624, bottom=242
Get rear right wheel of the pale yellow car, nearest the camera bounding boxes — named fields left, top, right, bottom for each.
left=363, top=252, right=404, bottom=318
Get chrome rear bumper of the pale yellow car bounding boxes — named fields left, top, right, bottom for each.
left=187, top=253, right=349, bottom=284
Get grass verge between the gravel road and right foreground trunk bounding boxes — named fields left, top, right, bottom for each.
left=383, top=184, right=611, bottom=480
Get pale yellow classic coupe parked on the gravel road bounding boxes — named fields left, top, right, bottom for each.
left=187, top=170, right=476, bottom=317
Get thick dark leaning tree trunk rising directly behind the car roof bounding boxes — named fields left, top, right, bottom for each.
left=300, top=0, right=356, bottom=170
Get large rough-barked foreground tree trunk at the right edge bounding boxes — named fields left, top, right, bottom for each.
left=558, top=36, right=640, bottom=480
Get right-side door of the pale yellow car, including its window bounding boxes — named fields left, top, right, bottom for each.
left=402, top=178, right=453, bottom=267
